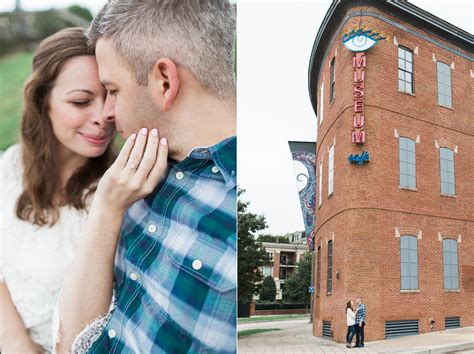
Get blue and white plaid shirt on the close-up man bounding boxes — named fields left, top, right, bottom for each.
left=89, top=137, right=237, bottom=353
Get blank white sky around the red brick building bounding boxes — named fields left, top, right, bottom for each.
left=237, top=0, right=474, bottom=234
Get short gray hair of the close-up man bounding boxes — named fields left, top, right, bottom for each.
left=88, top=0, right=236, bottom=98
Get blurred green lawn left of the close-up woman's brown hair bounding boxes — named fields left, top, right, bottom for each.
left=0, top=53, right=33, bottom=150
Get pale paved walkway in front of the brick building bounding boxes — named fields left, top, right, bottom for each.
left=238, top=319, right=474, bottom=354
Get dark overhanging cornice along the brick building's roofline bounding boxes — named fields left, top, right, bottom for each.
left=308, top=0, right=474, bottom=113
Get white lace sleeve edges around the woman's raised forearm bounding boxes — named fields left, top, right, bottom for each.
left=52, top=290, right=117, bottom=354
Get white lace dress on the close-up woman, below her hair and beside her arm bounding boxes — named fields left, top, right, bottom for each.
left=0, top=145, right=87, bottom=352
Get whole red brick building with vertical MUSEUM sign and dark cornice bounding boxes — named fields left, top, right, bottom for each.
left=309, top=0, right=474, bottom=342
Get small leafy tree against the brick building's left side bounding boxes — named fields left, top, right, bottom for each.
left=283, top=252, right=312, bottom=304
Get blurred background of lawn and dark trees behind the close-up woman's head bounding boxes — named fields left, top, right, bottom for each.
left=0, top=1, right=92, bottom=150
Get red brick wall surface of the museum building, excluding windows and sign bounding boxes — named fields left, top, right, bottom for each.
left=314, top=7, right=474, bottom=342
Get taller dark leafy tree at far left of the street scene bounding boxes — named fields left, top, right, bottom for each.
left=237, top=188, right=269, bottom=303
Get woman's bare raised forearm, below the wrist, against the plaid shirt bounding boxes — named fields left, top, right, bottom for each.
left=57, top=200, right=123, bottom=352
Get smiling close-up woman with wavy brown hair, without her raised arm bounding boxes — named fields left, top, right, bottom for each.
left=0, top=28, right=115, bottom=353
